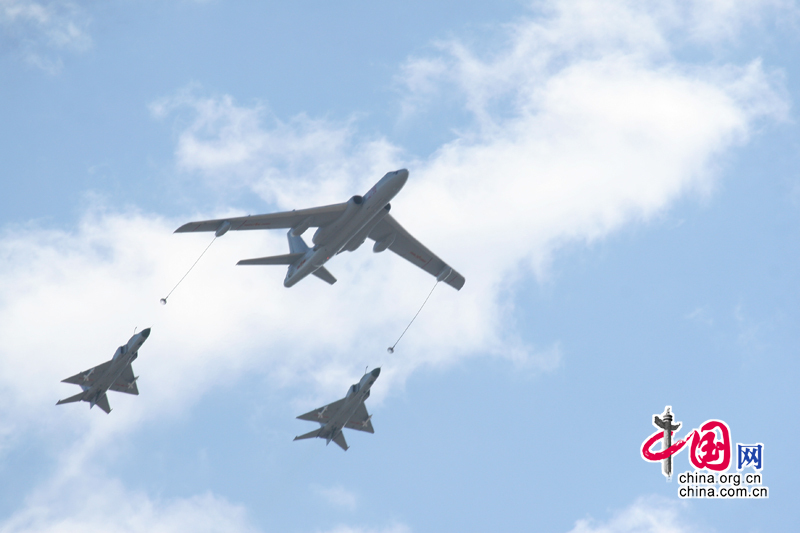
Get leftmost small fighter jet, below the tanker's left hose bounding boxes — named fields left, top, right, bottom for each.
left=56, top=328, right=150, bottom=413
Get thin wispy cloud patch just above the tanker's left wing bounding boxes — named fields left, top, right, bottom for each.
left=151, top=85, right=400, bottom=207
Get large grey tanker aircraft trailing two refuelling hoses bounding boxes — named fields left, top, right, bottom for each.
left=175, top=169, right=464, bottom=290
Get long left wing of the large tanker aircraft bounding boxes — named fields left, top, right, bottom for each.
left=175, top=202, right=347, bottom=233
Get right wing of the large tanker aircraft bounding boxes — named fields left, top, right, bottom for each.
left=368, top=215, right=465, bottom=290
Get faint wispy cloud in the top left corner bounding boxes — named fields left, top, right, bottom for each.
left=0, top=0, right=92, bottom=73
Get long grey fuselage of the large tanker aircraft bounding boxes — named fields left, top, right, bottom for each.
left=283, top=169, right=408, bottom=287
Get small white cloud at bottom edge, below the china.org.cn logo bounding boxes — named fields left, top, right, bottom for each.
left=569, top=497, right=698, bottom=533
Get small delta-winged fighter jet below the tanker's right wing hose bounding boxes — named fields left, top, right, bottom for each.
left=294, top=368, right=381, bottom=451
